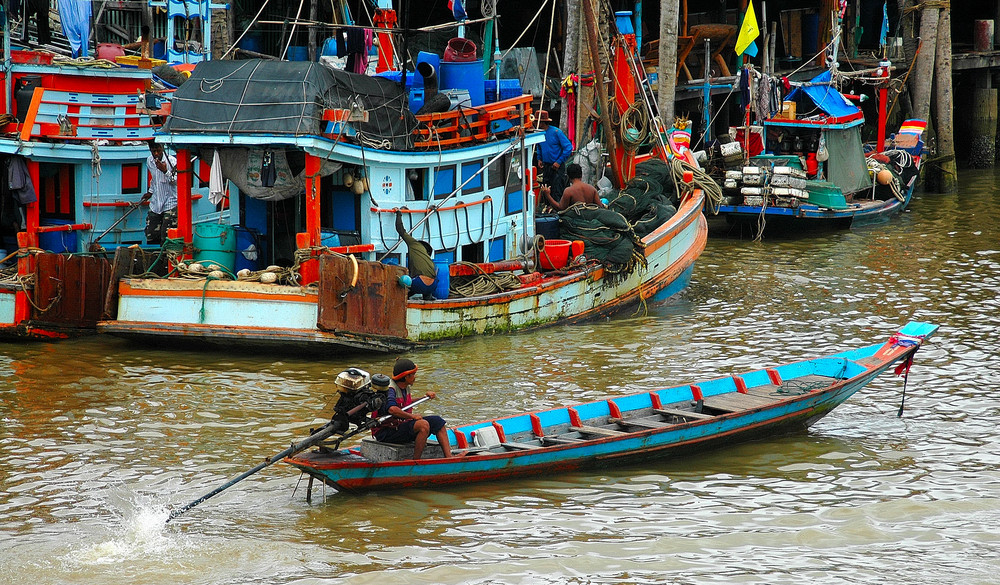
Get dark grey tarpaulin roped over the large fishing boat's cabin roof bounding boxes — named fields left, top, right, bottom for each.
left=163, top=59, right=416, bottom=150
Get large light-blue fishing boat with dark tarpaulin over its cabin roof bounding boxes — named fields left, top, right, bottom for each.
left=92, top=11, right=707, bottom=353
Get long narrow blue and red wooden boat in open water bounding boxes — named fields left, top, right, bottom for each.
left=284, top=322, right=937, bottom=491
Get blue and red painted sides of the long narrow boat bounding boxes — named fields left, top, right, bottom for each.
left=285, top=322, right=937, bottom=491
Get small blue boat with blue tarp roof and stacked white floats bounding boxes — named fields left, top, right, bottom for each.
left=713, top=72, right=926, bottom=237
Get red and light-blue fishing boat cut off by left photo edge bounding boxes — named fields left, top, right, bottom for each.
left=0, top=48, right=162, bottom=339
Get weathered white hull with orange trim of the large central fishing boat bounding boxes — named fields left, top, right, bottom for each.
left=99, top=191, right=708, bottom=353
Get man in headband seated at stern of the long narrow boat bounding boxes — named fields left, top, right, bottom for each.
left=372, top=358, right=452, bottom=459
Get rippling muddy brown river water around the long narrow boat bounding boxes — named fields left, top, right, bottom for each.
left=0, top=171, right=1000, bottom=585
